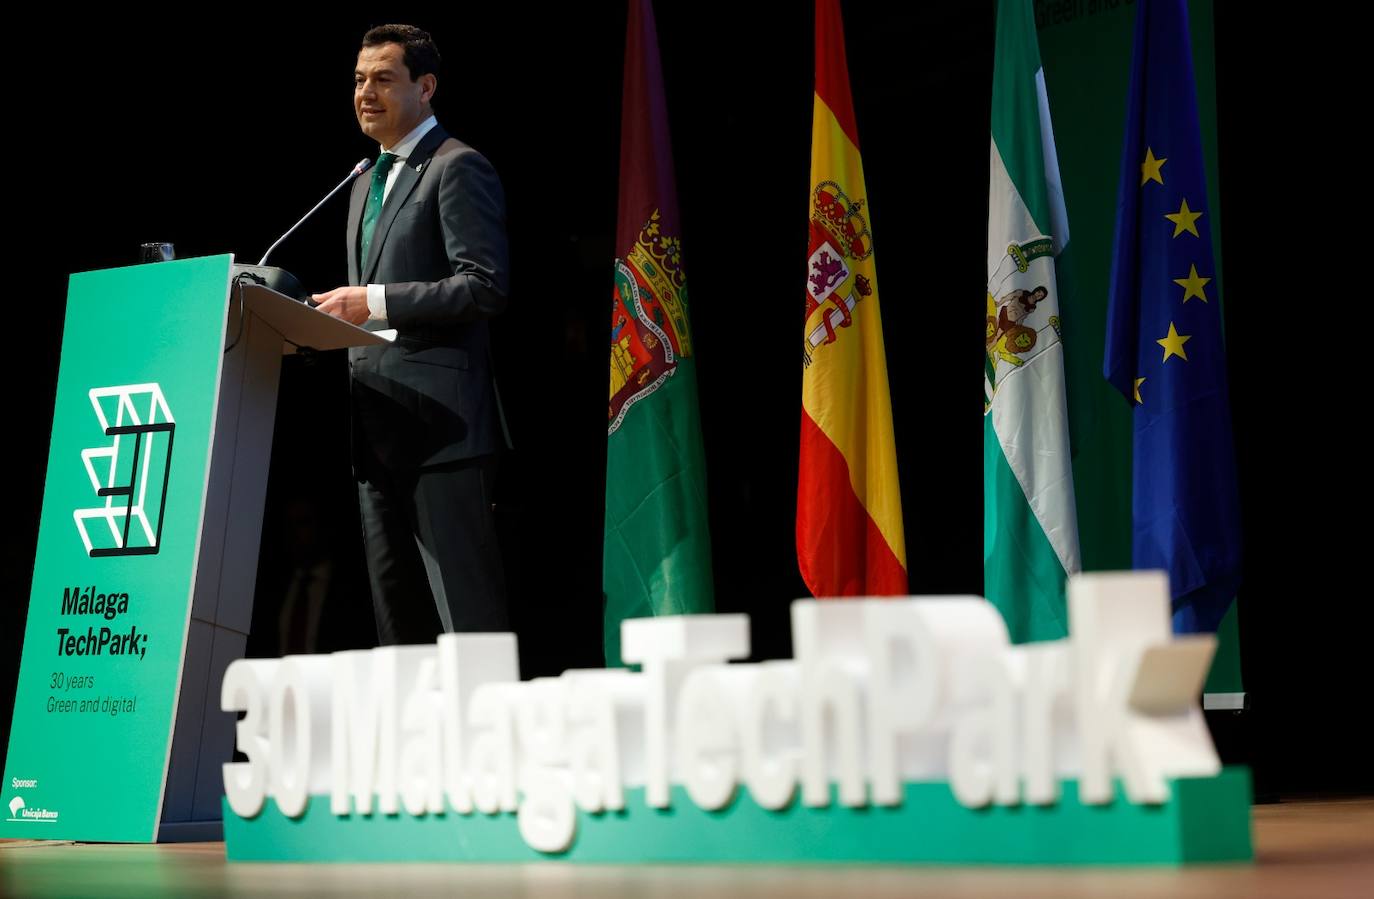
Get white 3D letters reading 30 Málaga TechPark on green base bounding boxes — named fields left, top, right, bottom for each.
left=221, top=572, right=1220, bottom=854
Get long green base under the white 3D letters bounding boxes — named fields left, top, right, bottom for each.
left=224, top=768, right=1253, bottom=865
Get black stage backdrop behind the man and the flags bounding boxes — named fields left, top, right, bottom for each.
left=0, top=0, right=1369, bottom=788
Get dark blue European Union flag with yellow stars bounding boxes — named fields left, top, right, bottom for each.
left=1103, top=0, right=1241, bottom=632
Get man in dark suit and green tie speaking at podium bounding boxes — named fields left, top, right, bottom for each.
left=313, top=25, right=510, bottom=645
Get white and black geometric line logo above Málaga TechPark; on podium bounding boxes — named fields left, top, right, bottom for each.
left=73, top=384, right=176, bottom=557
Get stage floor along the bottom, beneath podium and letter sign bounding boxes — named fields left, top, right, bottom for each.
left=0, top=799, right=1374, bottom=899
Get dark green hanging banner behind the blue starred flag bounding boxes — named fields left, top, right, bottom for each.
left=1035, top=0, right=1243, bottom=693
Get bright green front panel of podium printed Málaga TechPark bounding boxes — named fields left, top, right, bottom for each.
left=0, top=256, right=232, bottom=841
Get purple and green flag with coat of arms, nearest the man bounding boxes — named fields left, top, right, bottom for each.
left=602, top=0, right=712, bottom=665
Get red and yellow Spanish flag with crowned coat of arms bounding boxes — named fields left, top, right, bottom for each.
left=797, top=0, right=907, bottom=597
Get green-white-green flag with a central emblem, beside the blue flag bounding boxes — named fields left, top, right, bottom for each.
left=982, top=0, right=1081, bottom=642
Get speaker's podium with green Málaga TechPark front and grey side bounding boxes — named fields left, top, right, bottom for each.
left=0, top=256, right=386, bottom=841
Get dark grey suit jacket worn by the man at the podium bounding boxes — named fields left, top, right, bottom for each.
left=348, top=125, right=510, bottom=478
